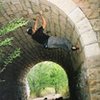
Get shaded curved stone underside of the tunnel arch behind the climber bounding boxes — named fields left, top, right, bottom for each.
left=0, top=0, right=98, bottom=100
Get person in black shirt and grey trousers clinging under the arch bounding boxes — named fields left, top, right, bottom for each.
left=27, top=11, right=79, bottom=51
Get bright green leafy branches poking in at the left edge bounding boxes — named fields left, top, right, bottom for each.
left=0, top=18, right=28, bottom=72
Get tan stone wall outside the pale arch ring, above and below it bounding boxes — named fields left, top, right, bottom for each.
left=73, top=0, right=100, bottom=100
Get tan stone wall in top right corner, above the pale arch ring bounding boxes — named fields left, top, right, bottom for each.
left=73, top=0, right=100, bottom=45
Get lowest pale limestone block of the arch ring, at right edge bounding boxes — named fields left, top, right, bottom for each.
left=84, top=43, right=100, bottom=57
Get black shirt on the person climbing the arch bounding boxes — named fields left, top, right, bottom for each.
left=32, top=26, right=50, bottom=44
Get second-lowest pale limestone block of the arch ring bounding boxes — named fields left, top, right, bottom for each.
left=80, top=30, right=97, bottom=46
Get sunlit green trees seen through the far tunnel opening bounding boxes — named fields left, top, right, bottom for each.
left=27, top=61, right=68, bottom=96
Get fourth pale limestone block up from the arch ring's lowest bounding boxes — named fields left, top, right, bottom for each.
left=68, top=7, right=85, bottom=23
